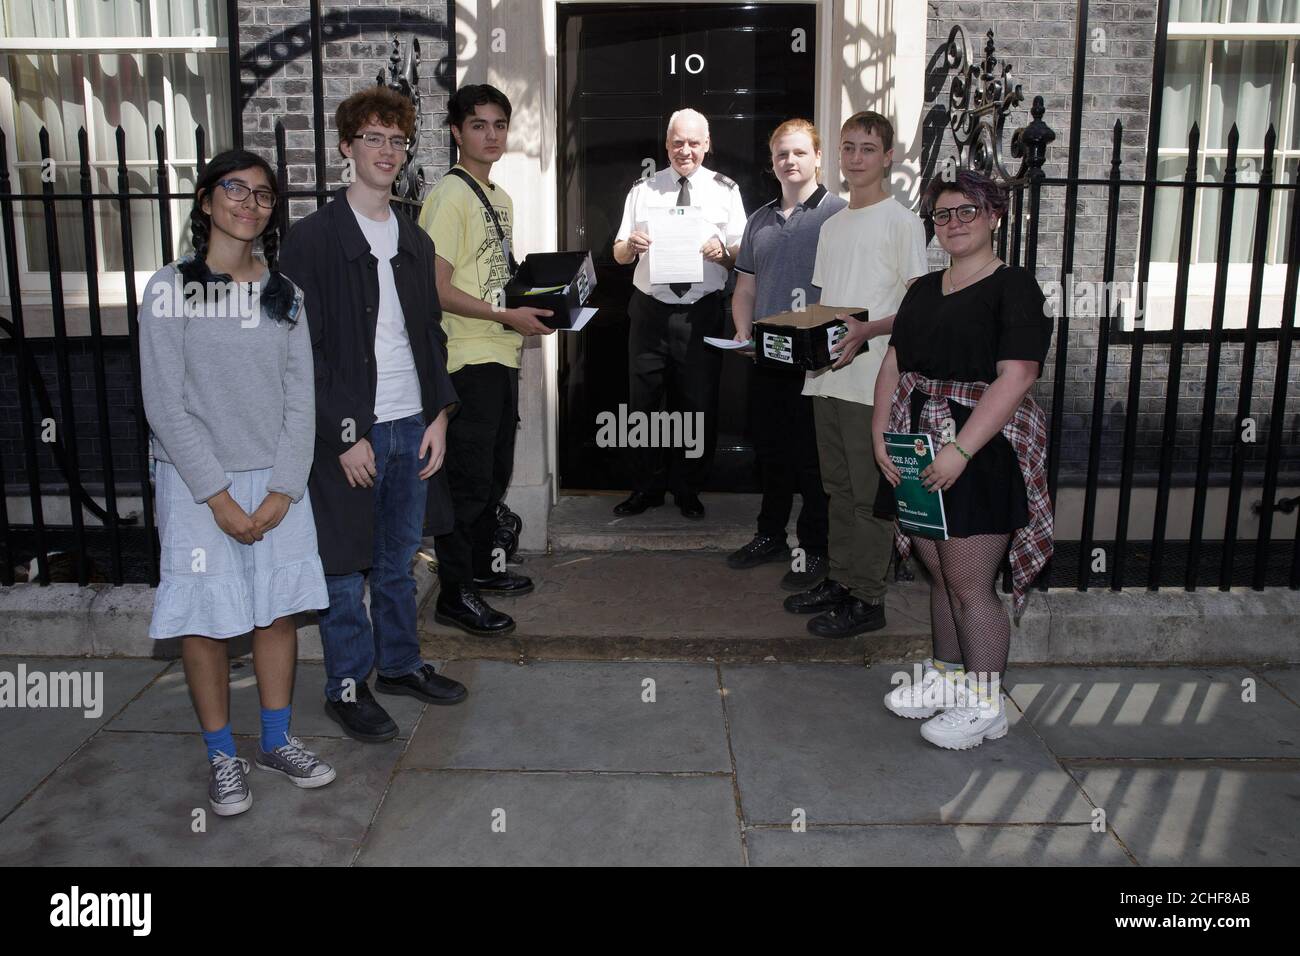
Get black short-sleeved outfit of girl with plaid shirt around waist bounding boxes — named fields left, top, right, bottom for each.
left=876, top=265, right=1052, bottom=537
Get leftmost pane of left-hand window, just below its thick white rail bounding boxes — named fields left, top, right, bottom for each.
left=5, top=53, right=86, bottom=163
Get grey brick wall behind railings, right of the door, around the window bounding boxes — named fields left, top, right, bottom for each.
left=924, top=0, right=1300, bottom=484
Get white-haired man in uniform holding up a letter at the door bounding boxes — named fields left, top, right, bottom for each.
left=614, top=109, right=745, bottom=518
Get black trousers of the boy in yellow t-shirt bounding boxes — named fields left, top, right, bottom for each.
left=433, top=362, right=519, bottom=587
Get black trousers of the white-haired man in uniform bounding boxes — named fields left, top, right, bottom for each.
left=628, top=289, right=723, bottom=494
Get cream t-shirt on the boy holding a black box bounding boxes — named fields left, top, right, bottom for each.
left=803, top=196, right=930, bottom=405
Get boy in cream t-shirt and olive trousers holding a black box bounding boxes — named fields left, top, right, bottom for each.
left=785, top=112, right=928, bottom=637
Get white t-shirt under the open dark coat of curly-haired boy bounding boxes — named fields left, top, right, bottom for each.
left=352, top=209, right=421, bottom=421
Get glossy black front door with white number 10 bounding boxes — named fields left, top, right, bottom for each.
left=559, top=4, right=816, bottom=492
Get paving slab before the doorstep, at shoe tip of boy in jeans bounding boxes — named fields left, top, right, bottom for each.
left=402, top=661, right=731, bottom=773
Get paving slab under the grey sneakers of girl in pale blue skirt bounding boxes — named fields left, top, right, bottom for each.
left=0, top=731, right=402, bottom=866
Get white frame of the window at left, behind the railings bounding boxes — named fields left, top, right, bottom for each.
left=0, top=0, right=238, bottom=307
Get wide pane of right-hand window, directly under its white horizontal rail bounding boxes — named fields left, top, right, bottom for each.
left=1201, top=40, right=1287, bottom=150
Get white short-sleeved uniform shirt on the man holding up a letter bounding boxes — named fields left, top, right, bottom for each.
left=614, top=166, right=746, bottom=306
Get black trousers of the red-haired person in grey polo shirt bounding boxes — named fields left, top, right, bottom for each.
left=749, top=365, right=827, bottom=555
